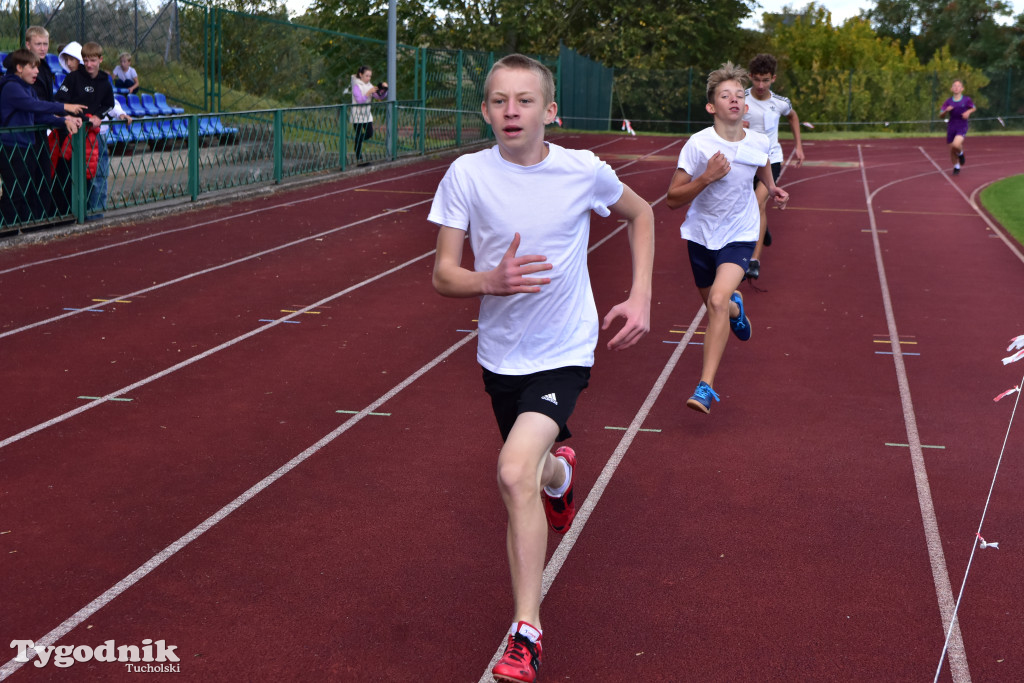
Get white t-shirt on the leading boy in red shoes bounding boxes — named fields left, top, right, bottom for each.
left=427, top=143, right=623, bottom=375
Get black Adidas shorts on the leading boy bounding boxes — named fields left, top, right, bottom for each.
left=483, top=366, right=590, bottom=441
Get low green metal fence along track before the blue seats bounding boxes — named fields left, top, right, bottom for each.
left=0, top=101, right=487, bottom=234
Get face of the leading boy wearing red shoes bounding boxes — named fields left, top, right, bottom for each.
left=480, top=68, right=558, bottom=163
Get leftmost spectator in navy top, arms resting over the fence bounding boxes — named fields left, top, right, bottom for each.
left=0, top=49, right=85, bottom=225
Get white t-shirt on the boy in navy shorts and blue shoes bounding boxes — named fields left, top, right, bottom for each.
left=678, top=127, right=771, bottom=250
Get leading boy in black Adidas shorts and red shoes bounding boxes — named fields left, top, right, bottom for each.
left=428, top=54, right=654, bottom=682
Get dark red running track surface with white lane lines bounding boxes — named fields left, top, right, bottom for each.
left=0, top=131, right=1024, bottom=683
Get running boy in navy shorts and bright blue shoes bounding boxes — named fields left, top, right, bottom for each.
left=666, top=61, right=790, bottom=413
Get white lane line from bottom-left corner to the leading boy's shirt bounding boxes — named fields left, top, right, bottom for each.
left=0, top=331, right=476, bottom=681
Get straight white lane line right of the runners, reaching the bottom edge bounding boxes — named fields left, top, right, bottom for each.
left=857, top=144, right=971, bottom=683
